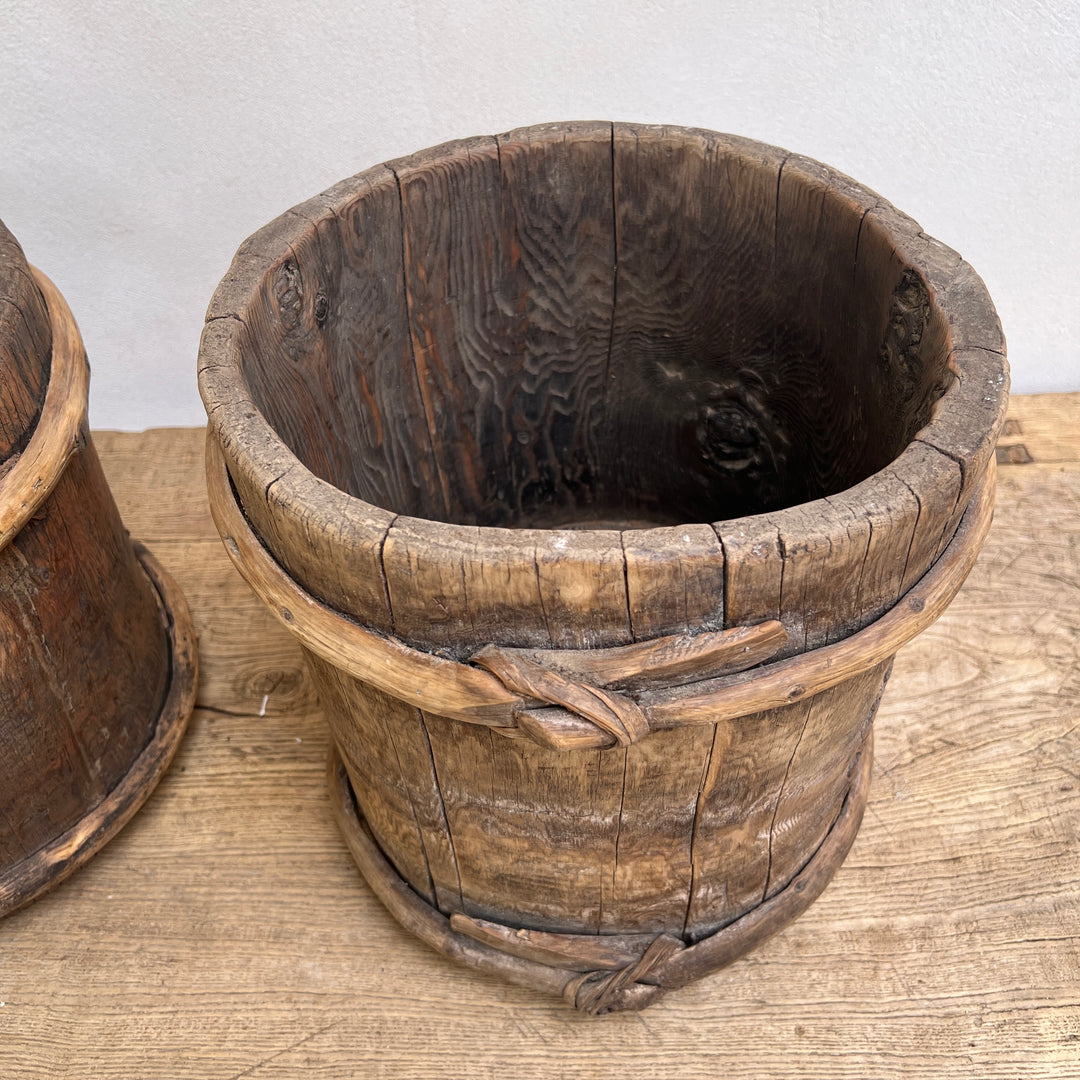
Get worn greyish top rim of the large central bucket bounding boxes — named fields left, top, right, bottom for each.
left=199, top=122, right=1009, bottom=549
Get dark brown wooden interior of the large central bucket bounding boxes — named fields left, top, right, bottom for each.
left=238, top=129, right=950, bottom=526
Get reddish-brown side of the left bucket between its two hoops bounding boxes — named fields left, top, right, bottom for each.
left=0, top=445, right=168, bottom=866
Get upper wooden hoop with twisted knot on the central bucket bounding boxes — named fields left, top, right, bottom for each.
left=206, top=432, right=996, bottom=751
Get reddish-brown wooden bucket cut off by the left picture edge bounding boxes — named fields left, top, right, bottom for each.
left=0, top=224, right=195, bottom=915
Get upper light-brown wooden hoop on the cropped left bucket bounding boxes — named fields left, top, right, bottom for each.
left=0, top=267, right=90, bottom=550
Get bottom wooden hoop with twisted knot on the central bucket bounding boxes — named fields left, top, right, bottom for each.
left=328, top=731, right=874, bottom=1014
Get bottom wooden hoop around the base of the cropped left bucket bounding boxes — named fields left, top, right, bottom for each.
left=0, top=543, right=199, bottom=917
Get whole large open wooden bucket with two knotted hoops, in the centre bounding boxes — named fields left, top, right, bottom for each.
left=200, top=123, right=1008, bottom=1012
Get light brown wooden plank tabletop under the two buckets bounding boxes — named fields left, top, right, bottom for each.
left=0, top=394, right=1080, bottom=1080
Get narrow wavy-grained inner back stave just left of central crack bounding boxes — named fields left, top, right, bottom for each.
left=490, top=123, right=621, bottom=525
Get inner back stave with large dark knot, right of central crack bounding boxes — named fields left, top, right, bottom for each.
left=606, top=124, right=789, bottom=523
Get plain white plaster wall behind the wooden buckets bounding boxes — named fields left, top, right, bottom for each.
left=0, top=0, right=1080, bottom=429
